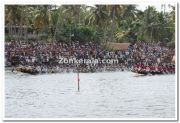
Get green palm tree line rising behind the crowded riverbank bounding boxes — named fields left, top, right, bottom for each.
left=5, top=4, right=175, bottom=46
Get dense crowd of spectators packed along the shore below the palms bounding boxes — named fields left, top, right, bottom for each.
left=5, top=41, right=175, bottom=73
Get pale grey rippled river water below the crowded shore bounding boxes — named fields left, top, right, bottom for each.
left=5, top=71, right=175, bottom=118
